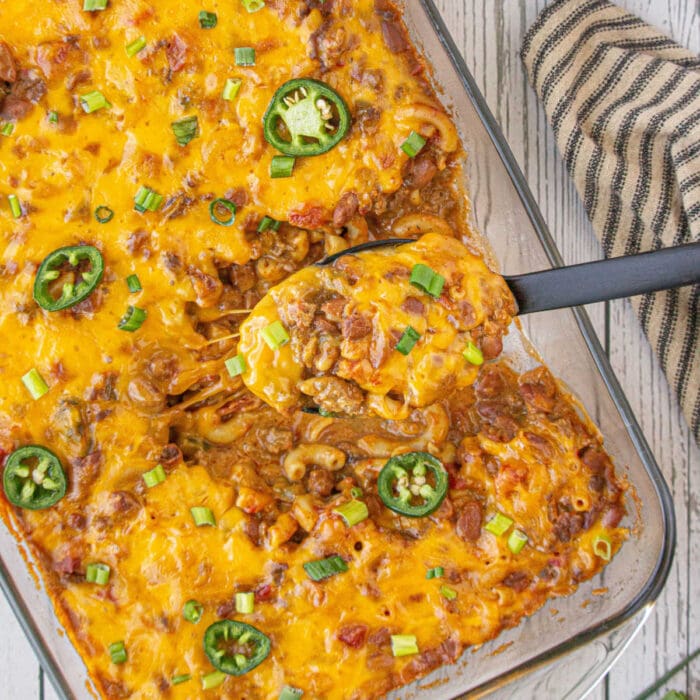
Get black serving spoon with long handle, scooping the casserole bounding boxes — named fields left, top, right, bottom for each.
left=316, top=238, right=700, bottom=316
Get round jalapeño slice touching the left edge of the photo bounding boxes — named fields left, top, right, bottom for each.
left=2, top=445, right=66, bottom=510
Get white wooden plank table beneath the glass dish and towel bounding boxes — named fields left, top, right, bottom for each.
left=0, top=0, right=700, bottom=700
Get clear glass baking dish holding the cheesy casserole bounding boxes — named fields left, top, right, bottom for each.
left=0, top=0, right=675, bottom=700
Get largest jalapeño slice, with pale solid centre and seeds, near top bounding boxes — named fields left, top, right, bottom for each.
left=263, top=78, right=350, bottom=156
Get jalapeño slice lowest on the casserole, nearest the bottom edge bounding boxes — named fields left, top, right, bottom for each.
left=204, top=620, right=270, bottom=676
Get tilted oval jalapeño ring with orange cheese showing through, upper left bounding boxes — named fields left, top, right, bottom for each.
left=34, top=245, right=104, bottom=311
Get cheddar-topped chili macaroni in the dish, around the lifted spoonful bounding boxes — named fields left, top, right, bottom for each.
left=0, top=0, right=626, bottom=700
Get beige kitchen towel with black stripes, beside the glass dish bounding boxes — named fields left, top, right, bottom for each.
left=522, top=0, right=700, bottom=444
